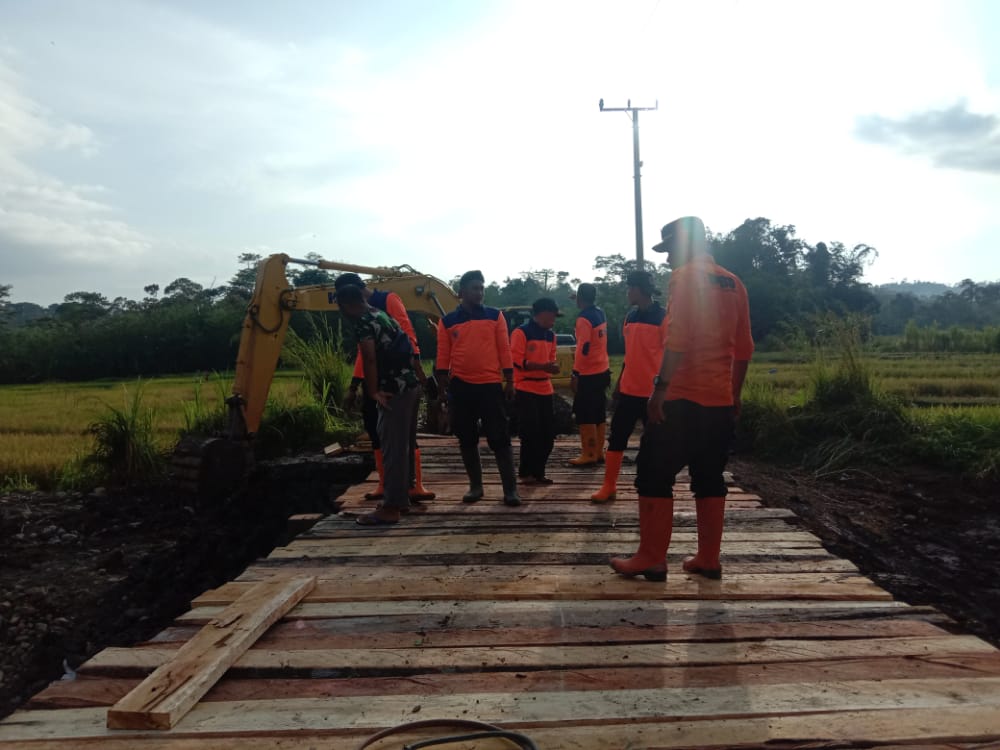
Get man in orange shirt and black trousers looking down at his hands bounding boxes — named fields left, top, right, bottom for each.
left=510, top=297, right=562, bottom=484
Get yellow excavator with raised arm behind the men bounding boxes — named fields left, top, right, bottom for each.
left=173, top=253, right=575, bottom=495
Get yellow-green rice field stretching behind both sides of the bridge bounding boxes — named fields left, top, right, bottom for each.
left=0, top=352, right=1000, bottom=490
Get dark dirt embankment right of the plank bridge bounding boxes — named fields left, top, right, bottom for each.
left=730, top=459, right=1000, bottom=646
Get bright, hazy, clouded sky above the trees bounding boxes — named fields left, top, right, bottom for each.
left=0, top=0, right=1000, bottom=304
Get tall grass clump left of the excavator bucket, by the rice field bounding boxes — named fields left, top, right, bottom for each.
left=75, top=381, right=165, bottom=487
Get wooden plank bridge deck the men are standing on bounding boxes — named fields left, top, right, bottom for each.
left=0, top=438, right=1000, bottom=750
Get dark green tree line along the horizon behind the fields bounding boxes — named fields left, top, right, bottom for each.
left=0, top=218, right=1000, bottom=383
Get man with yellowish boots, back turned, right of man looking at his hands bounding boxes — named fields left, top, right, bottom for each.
left=569, top=284, right=611, bottom=466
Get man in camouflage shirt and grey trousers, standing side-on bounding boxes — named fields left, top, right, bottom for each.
left=337, top=284, right=420, bottom=526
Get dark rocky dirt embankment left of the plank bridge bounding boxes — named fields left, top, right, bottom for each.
left=0, top=456, right=370, bottom=717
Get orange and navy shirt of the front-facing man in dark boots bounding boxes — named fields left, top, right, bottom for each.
left=435, top=305, right=513, bottom=383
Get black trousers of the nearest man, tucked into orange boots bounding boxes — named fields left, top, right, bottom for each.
left=635, top=399, right=735, bottom=498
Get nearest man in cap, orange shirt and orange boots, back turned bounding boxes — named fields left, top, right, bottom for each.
left=611, top=216, right=754, bottom=581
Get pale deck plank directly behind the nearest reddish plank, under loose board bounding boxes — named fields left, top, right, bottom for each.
left=77, top=636, right=1000, bottom=680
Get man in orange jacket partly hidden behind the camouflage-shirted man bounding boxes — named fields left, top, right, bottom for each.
left=333, top=273, right=434, bottom=502
